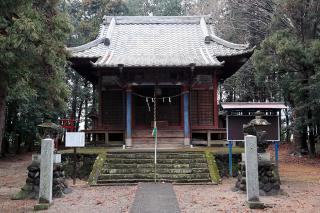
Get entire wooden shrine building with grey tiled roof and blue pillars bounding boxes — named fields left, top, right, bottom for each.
left=68, top=16, right=253, bottom=148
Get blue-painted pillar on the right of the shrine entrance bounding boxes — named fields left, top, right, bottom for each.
left=183, top=86, right=190, bottom=146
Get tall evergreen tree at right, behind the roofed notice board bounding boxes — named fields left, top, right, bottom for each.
left=254, top=0, right=320, bottom=156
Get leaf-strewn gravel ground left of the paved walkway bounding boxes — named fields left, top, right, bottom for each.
left=0, top=154, right=137, bottom=213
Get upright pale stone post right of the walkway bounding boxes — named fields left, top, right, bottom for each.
left=244, top=135, right=264, bottom=209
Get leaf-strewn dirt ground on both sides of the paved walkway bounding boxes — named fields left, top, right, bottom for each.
left=0, top=146, right=320, bottom=213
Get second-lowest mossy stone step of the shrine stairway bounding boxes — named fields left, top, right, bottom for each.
left=98, top=173, right=210, bottom=180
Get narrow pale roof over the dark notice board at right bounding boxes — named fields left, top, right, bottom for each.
left=221, top=102, right=288, bottom=110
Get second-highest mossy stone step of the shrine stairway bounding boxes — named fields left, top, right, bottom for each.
left=105, top=158, right=207, bottom=165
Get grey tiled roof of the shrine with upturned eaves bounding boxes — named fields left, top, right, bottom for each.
left=68, top=16, right=253, bottom=67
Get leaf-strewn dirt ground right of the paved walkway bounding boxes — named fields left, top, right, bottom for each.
left=174, top=145, right=320, bottom=213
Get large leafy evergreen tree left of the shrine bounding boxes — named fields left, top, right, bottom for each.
left=0, top=0, right=71, bottom=156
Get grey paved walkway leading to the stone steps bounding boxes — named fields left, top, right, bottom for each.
left=130, top=183, right=180, bottom=213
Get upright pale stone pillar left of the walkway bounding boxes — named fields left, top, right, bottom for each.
left=39, top=138, right=54, bottom=204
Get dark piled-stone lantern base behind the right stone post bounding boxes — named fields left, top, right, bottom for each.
left=235, top=161, right=280, bottom=196
